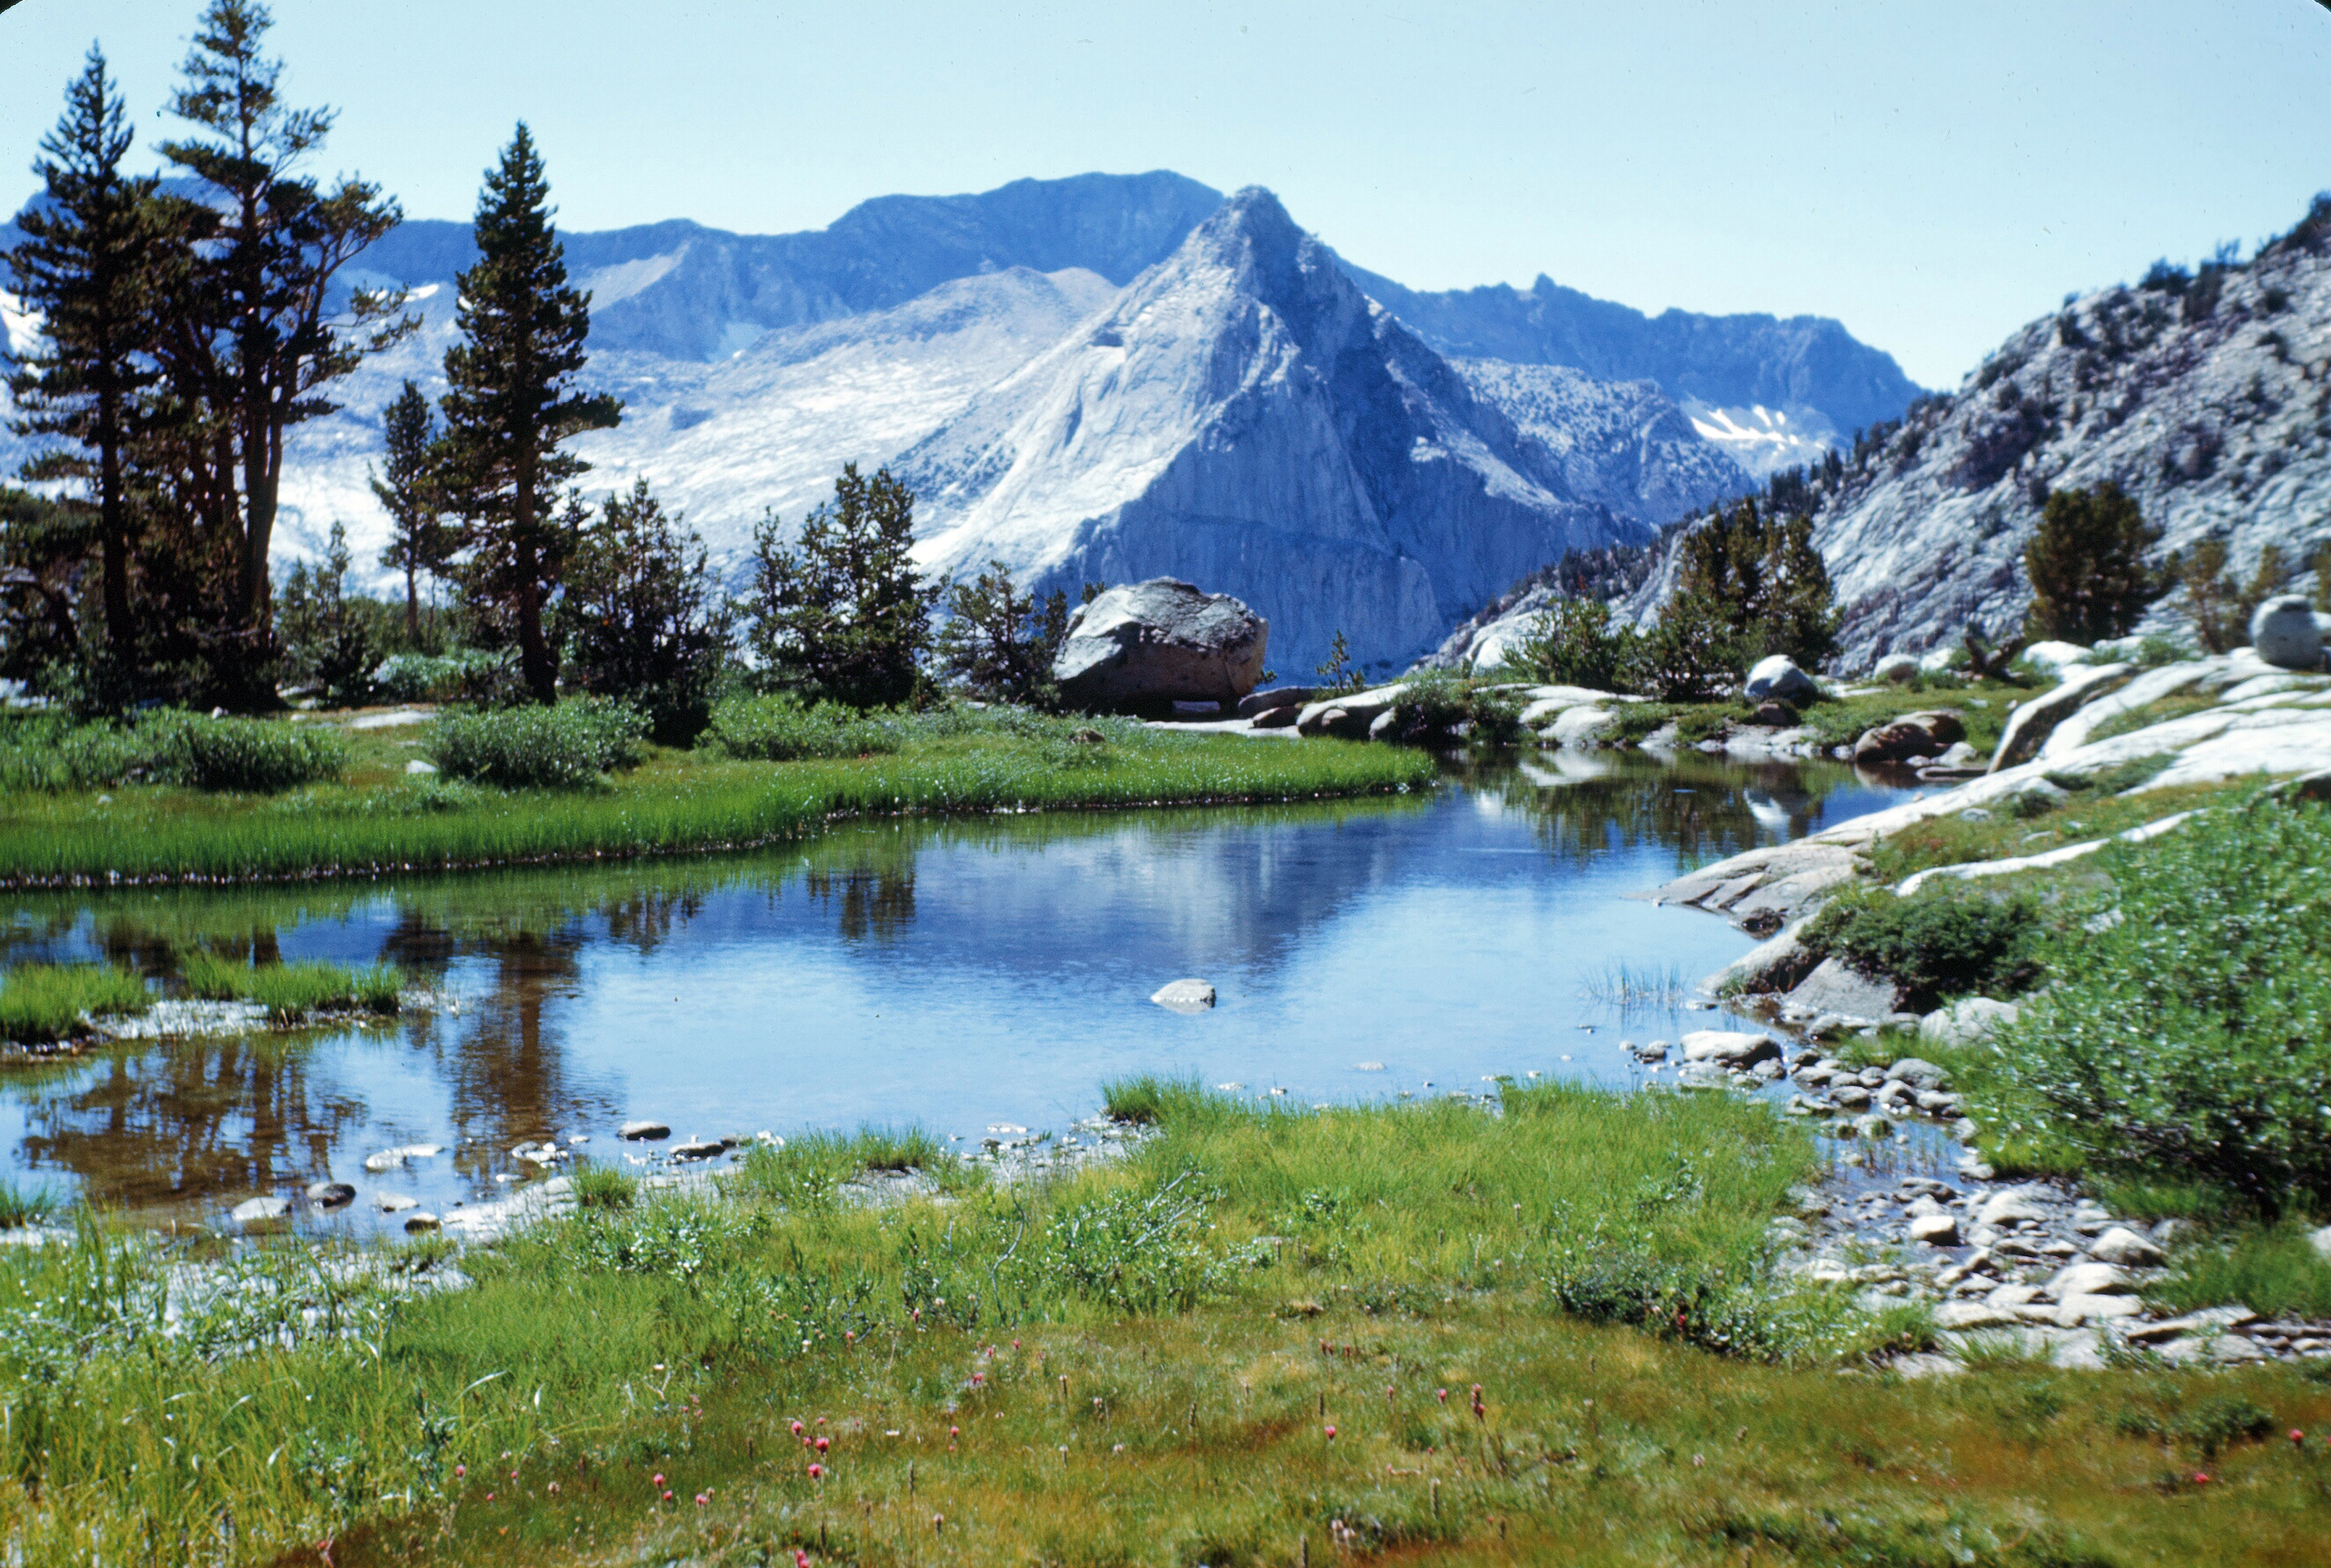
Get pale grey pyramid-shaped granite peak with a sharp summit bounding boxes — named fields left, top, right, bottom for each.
left=900, top=189, right=1739, bottom=671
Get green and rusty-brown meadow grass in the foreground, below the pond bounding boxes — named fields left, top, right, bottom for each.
left=13, top=1078, right=2331, bottom=1568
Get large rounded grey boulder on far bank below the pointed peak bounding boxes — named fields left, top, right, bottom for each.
left=1051, top=578, right=1270, bottom=711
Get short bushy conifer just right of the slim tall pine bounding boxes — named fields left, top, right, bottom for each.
left=559, top=480, right=734, bottom=746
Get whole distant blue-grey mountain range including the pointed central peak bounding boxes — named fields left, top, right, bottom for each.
left=0, top=172, right=1907, bottom=669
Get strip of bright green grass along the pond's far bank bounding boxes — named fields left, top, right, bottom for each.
left=0, top=715, right=1436, bottom=888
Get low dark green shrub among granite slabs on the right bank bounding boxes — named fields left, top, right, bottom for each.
left=1805, top=880, right=2039, bottom=1004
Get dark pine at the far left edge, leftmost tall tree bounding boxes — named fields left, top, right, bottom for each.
left=9, top=47, right=161, bottom=673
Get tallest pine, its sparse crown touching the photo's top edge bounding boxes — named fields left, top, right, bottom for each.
left=161, top=0, right=417, bottom=652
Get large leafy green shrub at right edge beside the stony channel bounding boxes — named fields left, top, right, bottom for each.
left=1974, top=801, right=2331, bottom=1214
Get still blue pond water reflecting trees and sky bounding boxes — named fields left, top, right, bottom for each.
left=0, top=755, right=1902, bottom=1228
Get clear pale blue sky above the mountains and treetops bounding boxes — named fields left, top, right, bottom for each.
left=0, top=0, right=2331, bottom=384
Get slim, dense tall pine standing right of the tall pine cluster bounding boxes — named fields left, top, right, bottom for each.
left=440, top=121, right=623, bottom=703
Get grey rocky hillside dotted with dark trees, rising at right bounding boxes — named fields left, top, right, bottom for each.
left=1814, top=203, right=2331, bottom=669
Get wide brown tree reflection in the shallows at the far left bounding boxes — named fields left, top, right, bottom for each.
left=14, top=1037, right=366, bottom=1207
